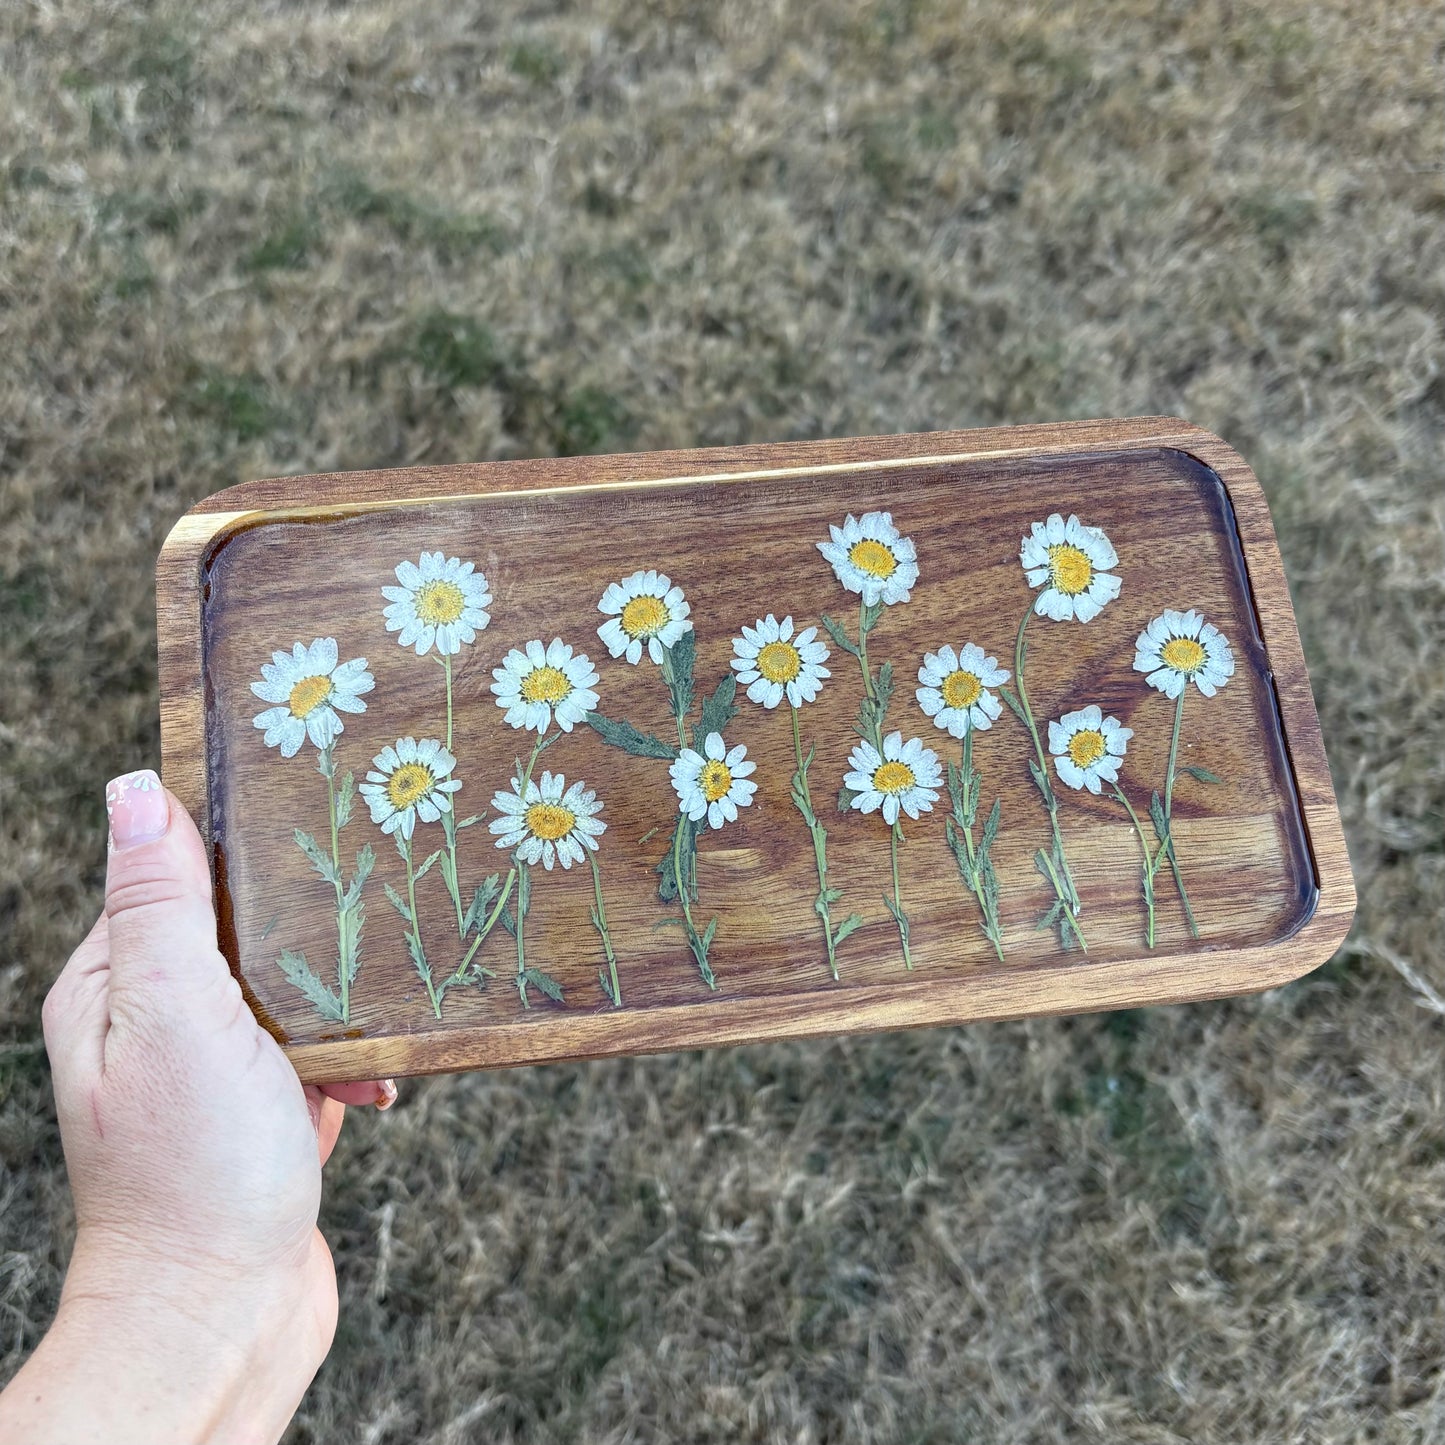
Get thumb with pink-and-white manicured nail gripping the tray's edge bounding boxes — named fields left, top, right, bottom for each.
left=105, top=769, right=230, bottom=1014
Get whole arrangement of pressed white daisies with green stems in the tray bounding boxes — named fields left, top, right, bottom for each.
left=242, top=512, right=1234, bottom=1025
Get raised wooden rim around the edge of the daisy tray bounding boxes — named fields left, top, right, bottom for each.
left=156, top=416, right=1355, bottom=1081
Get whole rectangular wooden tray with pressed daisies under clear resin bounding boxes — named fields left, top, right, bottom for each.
left=158, top=418, right=1354, bottom=1079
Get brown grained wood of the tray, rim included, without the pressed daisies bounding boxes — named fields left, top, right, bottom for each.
left=158, top=419, right=1354, bottom=1079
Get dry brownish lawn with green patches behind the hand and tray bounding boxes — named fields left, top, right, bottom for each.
left=0, top=0, right=1445, bottom=1445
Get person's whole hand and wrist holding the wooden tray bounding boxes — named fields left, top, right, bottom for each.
left=0, top=772, right=396, bottom=1445
